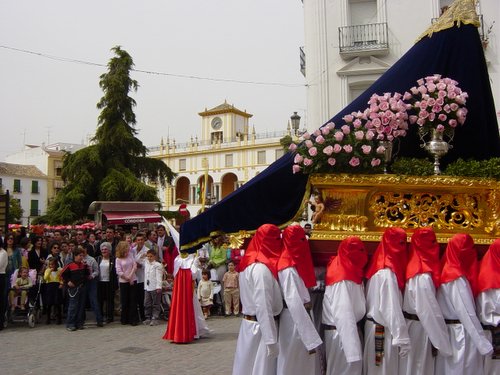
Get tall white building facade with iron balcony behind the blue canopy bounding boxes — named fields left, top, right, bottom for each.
left=301, top=0, right=500, bottom=130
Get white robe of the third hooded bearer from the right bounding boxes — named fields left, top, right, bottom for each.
left=399, top=273, right=451, bottom=375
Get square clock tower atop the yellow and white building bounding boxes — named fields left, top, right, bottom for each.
left=198, top=101, right=253, bottom=143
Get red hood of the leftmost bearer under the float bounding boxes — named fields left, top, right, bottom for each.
left=240, top=224, right=283, bottom=277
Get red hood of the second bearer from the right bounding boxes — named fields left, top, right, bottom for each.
left=441, top=233, right=479, bottom=296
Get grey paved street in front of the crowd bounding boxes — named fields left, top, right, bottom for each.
left=0, top=317, right=241, bottom=375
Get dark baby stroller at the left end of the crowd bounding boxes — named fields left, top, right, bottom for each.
left=4, top=270, right=43, bottom=328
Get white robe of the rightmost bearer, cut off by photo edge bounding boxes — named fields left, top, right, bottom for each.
left=476, top=290, right=500, bottom=375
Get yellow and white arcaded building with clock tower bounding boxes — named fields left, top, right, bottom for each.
left=149, top=102, right=290, bottom=216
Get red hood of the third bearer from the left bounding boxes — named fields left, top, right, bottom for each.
left=325, top=236, right=368, bottom=285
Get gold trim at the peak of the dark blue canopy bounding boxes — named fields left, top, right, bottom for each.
left=415, top=0, right=481, bottom=43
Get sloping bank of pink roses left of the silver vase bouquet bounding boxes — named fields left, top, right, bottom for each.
left=289, top=93, right=408, bottom=173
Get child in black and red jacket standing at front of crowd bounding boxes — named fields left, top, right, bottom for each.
left=61, top=247, right=90, bottom=331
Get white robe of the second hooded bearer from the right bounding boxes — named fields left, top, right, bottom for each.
left=436, top=277, right=493, bottom=375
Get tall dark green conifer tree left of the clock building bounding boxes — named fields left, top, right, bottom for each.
left=48, top=46, right=174, bottom=224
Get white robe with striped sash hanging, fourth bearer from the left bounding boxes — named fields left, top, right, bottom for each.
left=363, top=268, right=410, bottom=375
